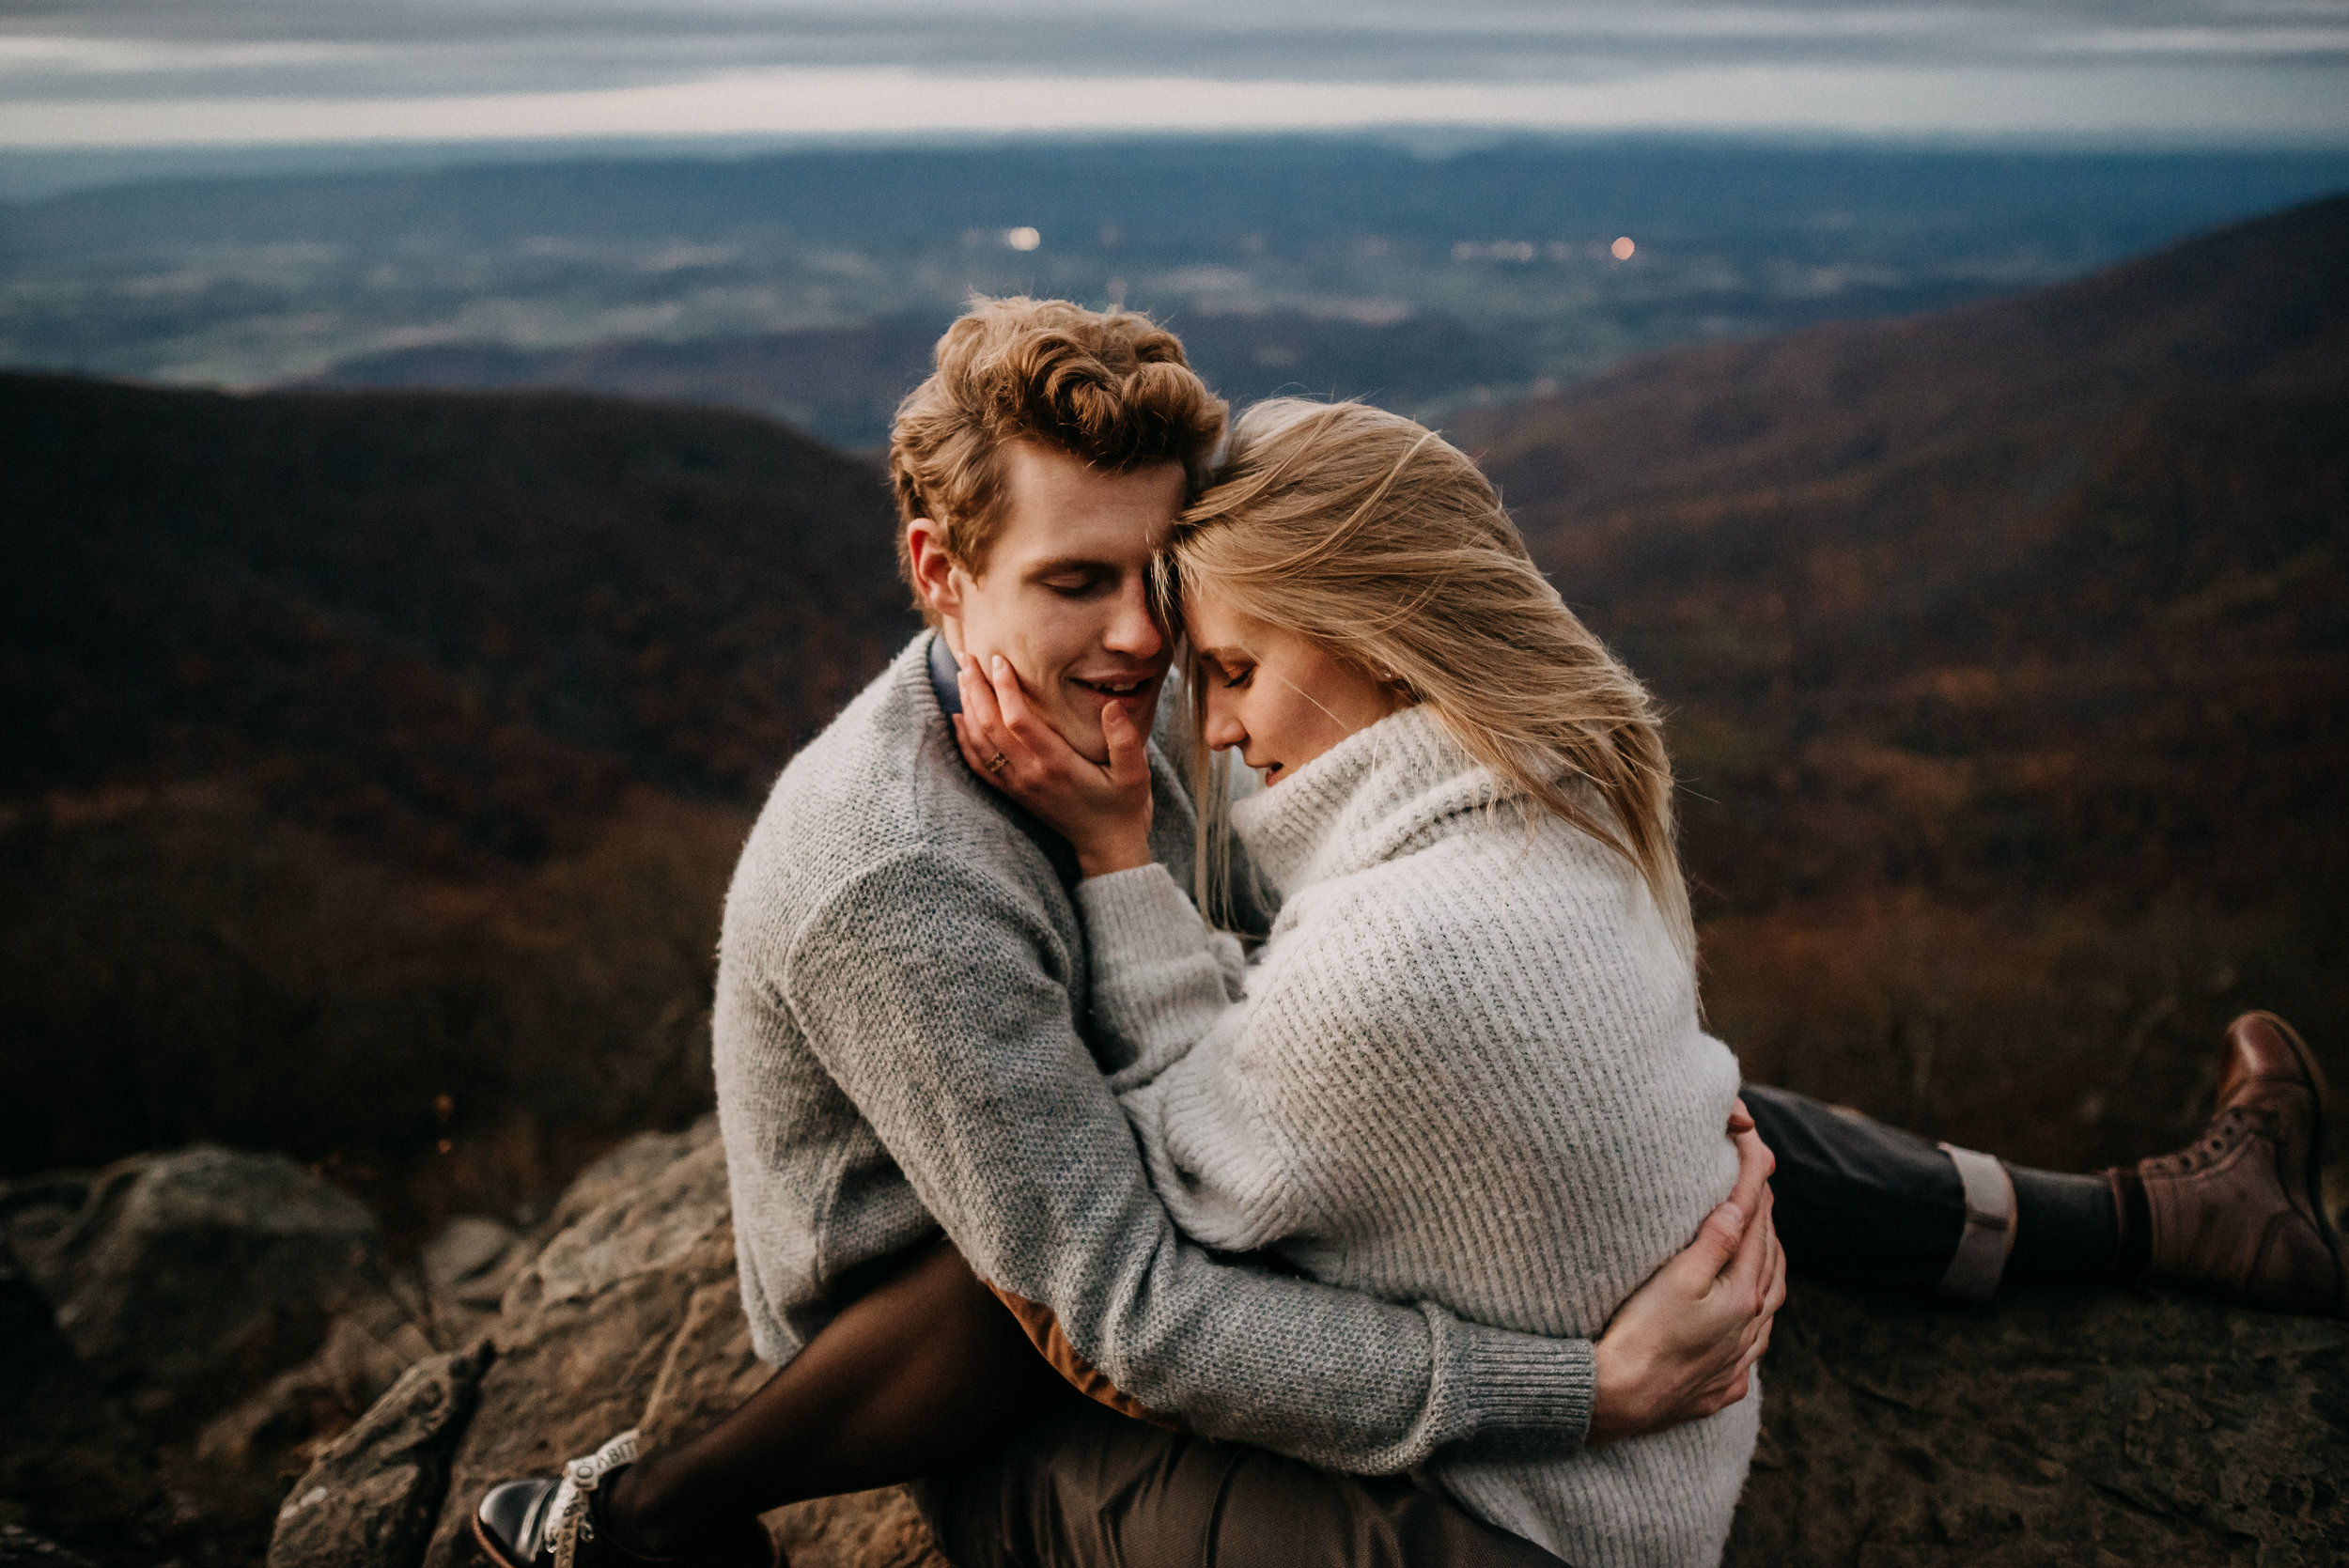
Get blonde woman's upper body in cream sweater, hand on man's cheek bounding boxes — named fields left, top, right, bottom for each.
left=961, top=401, right=1760, bottom=1568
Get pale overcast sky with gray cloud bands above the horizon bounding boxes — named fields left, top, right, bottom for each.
left=0, top=0, right=2349, bottom=147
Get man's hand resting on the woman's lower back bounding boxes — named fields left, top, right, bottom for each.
left=1588, top=1101, right=1785, bottom=1444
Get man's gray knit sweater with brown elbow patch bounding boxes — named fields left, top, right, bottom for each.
left=717, top=634, right=1593, bottom=1474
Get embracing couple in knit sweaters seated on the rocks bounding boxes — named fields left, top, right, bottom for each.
left=474, top=301, right=2344, bottom=1568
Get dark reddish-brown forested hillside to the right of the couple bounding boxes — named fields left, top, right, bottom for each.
left=1456, top=199, right=2349, bottom=1164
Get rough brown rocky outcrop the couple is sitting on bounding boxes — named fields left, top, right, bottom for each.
left=13, top=1125, right=2349, bottom=1568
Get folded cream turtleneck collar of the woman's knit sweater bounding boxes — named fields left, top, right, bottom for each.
left=1231, top=705, right=1494, bottom=899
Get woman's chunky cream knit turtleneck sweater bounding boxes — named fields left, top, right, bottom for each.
left=1079, top=706, right=1762, bottom=1568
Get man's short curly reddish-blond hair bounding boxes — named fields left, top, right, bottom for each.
left=888, top=298, right=1226, bottom=613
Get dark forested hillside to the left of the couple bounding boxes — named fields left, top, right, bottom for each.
left=0, top=376, right=914, bottom=1223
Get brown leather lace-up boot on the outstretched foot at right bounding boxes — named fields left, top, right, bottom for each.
left=2109, top=1012, right=2349, bottom=1317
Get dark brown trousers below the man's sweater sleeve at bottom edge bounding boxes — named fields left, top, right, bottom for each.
left=914, top=1399, right=1560, bottom=1568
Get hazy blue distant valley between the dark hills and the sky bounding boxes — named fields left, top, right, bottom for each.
left=0, top=136, right=2349, bottom=448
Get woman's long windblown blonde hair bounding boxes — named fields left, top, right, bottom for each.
left=1159, top=399, right=1696, bottom=957
